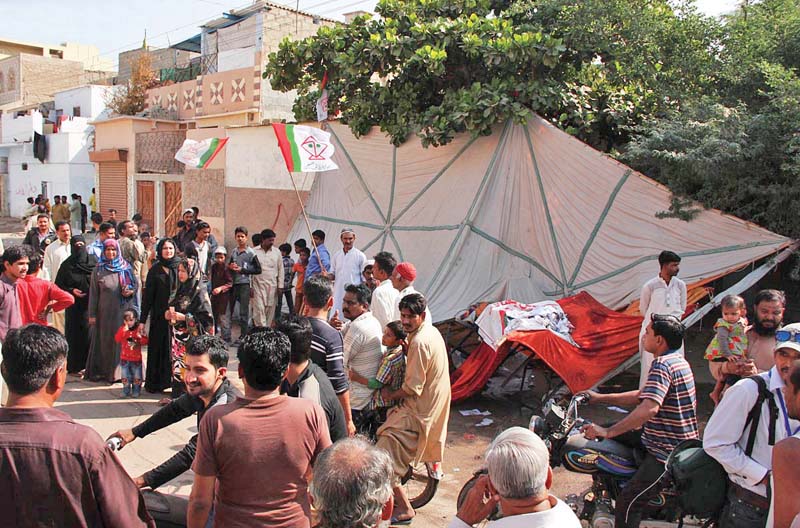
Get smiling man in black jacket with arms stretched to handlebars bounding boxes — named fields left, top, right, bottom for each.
left=108, top=335, right=239, bottom=489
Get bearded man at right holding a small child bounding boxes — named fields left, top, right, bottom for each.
left=708, top=290, right=786, bottom=388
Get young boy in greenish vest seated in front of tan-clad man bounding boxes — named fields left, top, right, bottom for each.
left=349, top=321, right=407, bottom=436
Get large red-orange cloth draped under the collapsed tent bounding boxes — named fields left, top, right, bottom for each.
left=450, top=292, right=642, bottom=401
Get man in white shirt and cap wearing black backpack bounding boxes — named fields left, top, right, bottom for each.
left=703, top=323, right=800, bottom=528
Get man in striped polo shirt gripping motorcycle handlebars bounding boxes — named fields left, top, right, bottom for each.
left=582, top=314, right=698, bottom=528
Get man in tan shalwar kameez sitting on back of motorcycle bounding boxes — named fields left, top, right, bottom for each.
left=378, top=293, right=450, bottom=522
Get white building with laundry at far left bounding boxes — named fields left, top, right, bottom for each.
left=0, top=85, right=113, bottom=216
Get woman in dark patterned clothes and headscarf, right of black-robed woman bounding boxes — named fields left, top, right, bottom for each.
left=164, top=259, right=214, bottom=399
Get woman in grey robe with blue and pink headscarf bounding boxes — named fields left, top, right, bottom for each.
left=84, top=238, right=136, bottom=383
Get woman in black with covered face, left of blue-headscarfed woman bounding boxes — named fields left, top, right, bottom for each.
left=56, top=235, right=97, bottom=374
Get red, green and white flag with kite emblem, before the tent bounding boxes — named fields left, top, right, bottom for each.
left=272, top=123, right=339, bottom=172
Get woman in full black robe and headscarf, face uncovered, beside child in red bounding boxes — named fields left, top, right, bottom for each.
left=139, top=238, right=181, bottom=393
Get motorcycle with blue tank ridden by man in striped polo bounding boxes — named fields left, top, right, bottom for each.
left=458, top=394, right=714, bottom=528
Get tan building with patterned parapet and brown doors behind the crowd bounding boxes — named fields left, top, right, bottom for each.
left=92, top=1, right=336, bottom=244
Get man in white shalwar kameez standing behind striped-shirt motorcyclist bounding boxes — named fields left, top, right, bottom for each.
left=639, top=251, right=686, bottom=389
